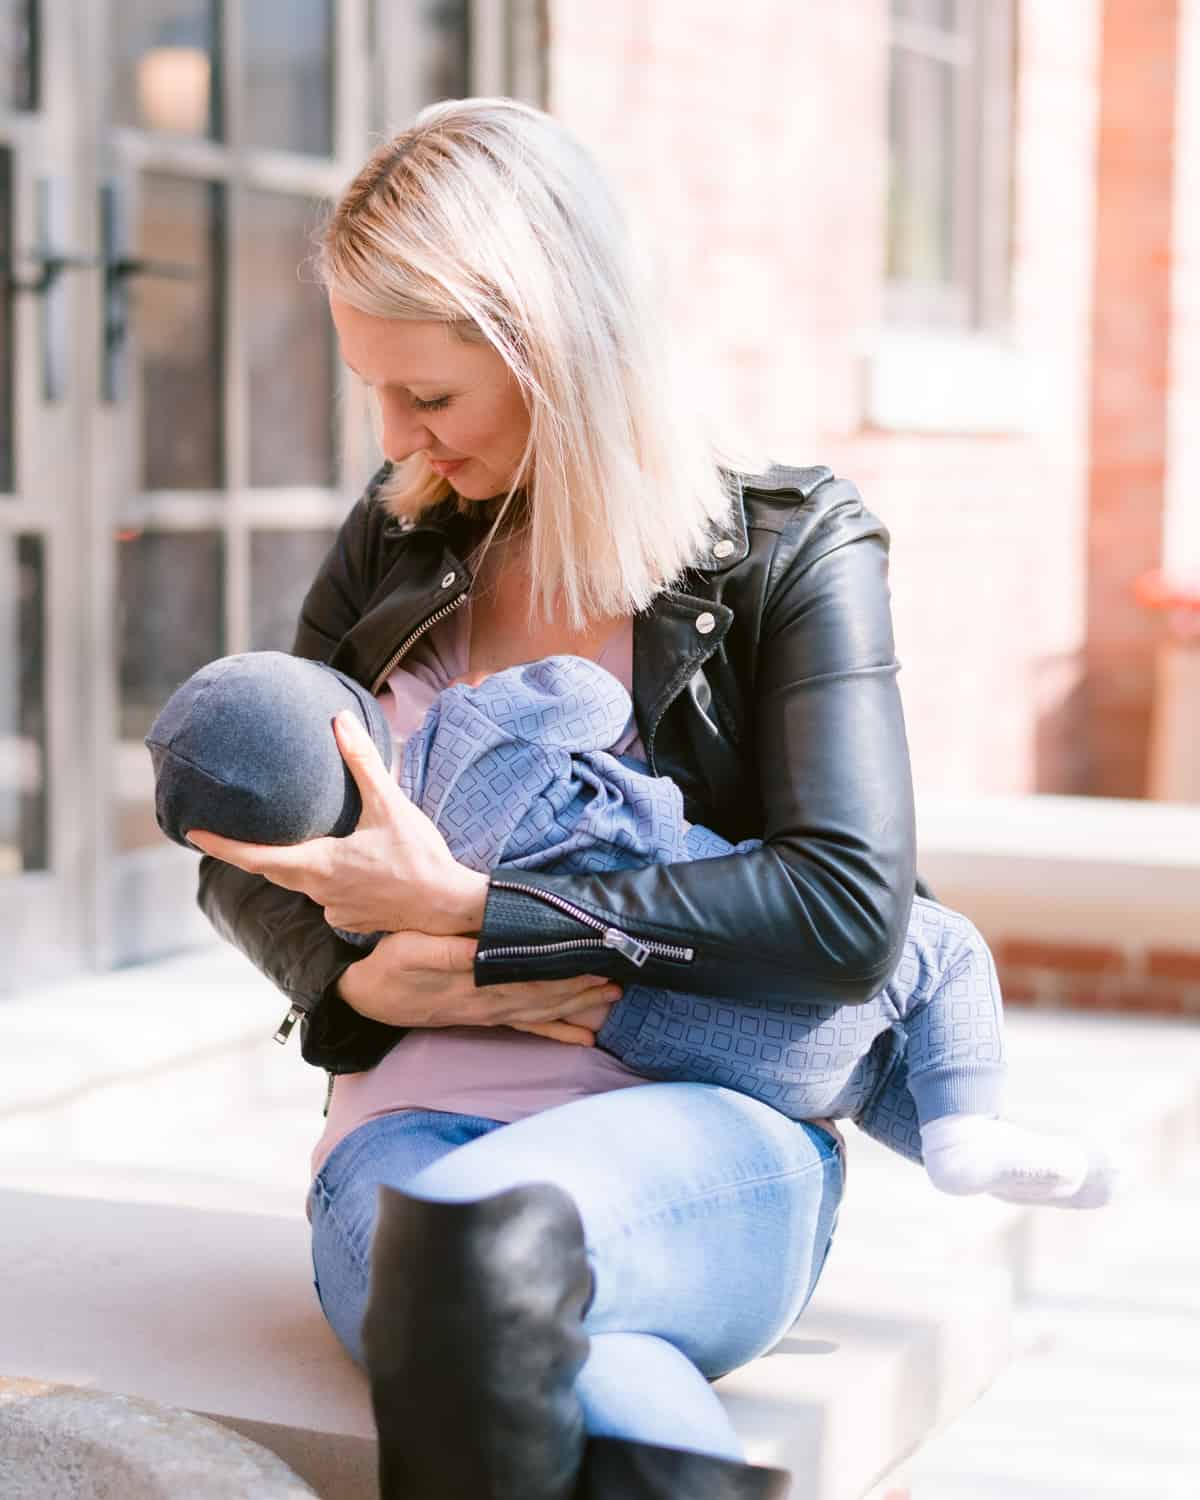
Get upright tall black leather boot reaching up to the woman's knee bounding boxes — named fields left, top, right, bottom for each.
left=363, top=1184, right=591, bottom=1500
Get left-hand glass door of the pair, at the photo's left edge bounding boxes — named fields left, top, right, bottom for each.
left=0, top=0, right=96, bottom=992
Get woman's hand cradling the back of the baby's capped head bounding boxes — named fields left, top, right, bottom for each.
left=188, top=713, right=488, bottom=936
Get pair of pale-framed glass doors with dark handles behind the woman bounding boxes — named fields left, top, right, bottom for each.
left=0, top=0, right=542, bottom=990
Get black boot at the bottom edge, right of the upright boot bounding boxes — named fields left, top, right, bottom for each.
left=576, top=1437, right=792, bottom=1500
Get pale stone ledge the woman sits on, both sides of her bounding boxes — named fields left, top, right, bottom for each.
left=0, top=1191, right=1011, bottom=1500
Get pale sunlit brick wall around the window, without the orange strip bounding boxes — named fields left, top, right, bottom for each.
left=551, top=0, right=1100, bottom=794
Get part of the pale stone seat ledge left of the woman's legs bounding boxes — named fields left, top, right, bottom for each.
left=0, top=1190, right=375, bottom=1500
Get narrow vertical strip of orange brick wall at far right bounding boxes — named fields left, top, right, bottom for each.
left=1086, top=0, right=1178, bottom=797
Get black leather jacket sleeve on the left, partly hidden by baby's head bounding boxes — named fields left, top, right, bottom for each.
left=198, top=476, right=402, bottom=1073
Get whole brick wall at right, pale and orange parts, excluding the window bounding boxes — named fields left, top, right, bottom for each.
left=549, top=0, right=1200, bottom=1016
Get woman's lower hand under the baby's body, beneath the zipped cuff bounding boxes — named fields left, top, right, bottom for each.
left=338, top=932, right=621, bottom=1046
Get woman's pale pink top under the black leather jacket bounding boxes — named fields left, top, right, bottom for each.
left=312, top=600, right=647, bottom=1175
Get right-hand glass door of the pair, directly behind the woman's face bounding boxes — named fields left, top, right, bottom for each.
left=92, top=0, right=368, bottom=963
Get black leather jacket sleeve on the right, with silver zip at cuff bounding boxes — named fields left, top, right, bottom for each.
left=476, top=482, right=915, bottom=1005
